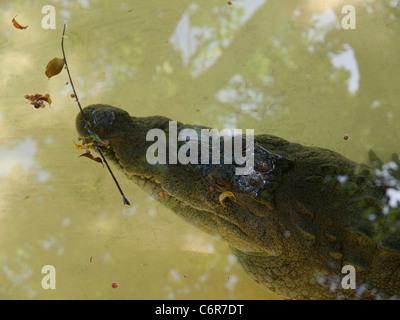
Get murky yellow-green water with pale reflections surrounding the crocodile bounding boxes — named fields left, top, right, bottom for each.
left=0, top=0, right=400, bottom=299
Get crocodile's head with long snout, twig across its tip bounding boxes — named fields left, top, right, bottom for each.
left=76, top=104, right=290, bottom=254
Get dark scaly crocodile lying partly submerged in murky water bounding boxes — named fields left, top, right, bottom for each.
left=76, top=104, right=400, bottom=299
